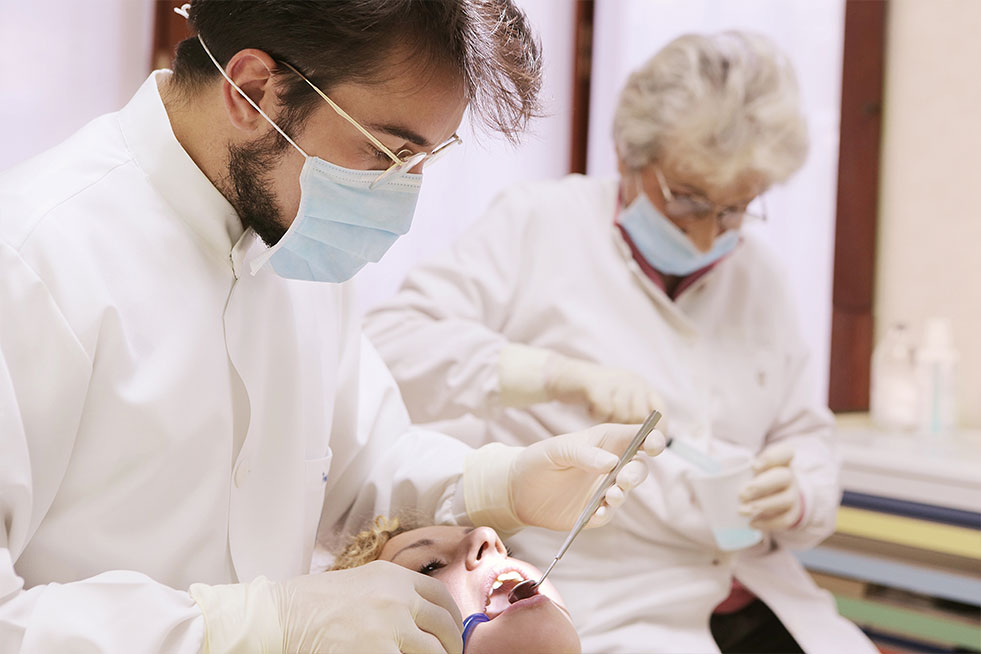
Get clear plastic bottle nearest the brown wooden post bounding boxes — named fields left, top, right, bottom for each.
left=869, top=323, right=920, bottom=431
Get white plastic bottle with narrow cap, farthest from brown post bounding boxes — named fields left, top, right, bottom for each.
left=916, top=318, right=957, bottom=434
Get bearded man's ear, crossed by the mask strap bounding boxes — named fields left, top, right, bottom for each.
left=221, top=48, right=278, bottom=136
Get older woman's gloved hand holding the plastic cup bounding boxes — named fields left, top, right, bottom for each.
left=739, top=444, right=804, bottom=531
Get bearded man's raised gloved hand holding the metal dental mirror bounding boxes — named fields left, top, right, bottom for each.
left=463, top=424, right=664, bottom=534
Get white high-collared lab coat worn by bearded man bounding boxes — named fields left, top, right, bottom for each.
left=0, top=72, right=469, bottom=654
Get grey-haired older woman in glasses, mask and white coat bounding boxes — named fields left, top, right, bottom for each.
left=367, top=32, right=875, bottom=652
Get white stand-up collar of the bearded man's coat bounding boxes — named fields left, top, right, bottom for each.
left=119, top=70, right=247, bottom=266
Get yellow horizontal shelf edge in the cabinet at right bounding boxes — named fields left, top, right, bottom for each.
left=835, top=506, right=981, bottom=560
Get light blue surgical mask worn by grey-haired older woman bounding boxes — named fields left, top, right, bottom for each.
left=620, top=192, right=739, bottom=276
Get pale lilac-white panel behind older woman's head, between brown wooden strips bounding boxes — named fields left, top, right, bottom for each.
left=588, top=0, right=844, bottom=404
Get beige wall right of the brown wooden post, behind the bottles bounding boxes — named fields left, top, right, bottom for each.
left=876, top=0, right=981, bottom=428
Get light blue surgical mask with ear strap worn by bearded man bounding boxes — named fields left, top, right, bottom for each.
left=198, top=36, right=422, bottom=282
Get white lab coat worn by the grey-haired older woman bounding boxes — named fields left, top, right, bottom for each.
left=366, top=175, right=875, bottom=652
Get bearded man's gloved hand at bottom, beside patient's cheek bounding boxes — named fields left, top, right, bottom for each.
left=190, top=561, right=463, bottom=654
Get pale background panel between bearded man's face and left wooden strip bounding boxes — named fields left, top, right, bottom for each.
left=356, top=0, right=575, bottom=309
